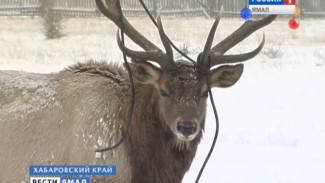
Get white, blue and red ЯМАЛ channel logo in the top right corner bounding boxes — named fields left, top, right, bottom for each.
left=249, top=0, right=296, bottom=15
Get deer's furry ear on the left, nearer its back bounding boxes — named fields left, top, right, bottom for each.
left=123, top=62, right=161, bottom=85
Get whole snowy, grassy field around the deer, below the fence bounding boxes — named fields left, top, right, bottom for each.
left=0, top=17, right=325, bottom=183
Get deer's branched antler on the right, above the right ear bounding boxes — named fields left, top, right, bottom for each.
left=198, top=14, right=276, bottom=67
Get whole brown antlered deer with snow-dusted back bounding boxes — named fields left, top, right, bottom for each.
left=0, top=0, right=276, bottom=183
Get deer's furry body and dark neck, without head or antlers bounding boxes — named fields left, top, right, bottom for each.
left=0, top=62, right=204, bottom=183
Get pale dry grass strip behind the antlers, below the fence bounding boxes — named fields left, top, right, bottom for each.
left=0, top=17, right=325, bottom=72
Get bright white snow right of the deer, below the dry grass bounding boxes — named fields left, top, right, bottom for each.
left=184, top=65, right=325, bottom=183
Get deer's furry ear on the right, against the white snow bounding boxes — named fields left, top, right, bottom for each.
left=210, top=64, right=244, bottom=88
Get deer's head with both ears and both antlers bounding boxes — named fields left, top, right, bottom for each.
left=96, top=0, right=276, bottom=146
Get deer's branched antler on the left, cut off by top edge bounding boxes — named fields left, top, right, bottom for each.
left=96, top=0, right=174, bottom=69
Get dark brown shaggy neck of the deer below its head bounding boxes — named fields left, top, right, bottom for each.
left=129, top=85, right=201, bottom=183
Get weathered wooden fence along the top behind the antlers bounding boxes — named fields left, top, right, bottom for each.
left=0, top=0, right=325, bottom=17
